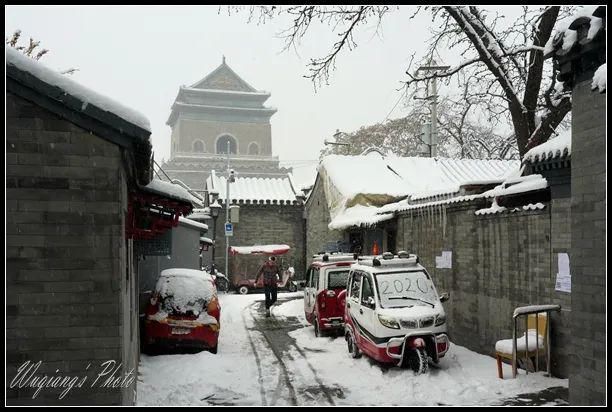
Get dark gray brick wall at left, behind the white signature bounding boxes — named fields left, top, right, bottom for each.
left=6, top=94, right=137, bottom=404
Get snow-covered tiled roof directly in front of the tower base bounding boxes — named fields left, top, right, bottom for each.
left=206, top=170, right=298, bottom=204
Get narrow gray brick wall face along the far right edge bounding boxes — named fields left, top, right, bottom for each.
left=569, top=79, right=606, bottom=405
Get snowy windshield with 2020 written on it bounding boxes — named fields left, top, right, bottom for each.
left=375, top=271, right=438, bottom=308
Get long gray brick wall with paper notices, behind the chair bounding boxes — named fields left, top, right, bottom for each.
left=397, top=199, right=571, bottom=377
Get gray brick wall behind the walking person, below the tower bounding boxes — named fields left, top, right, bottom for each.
left=209, top=204, right=305, bottom=279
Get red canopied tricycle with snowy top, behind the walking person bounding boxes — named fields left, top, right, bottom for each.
left=229, top=245, right=298, bottom=295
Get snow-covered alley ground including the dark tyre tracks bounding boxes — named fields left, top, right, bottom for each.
left=138, top=292, right=568, bottom=405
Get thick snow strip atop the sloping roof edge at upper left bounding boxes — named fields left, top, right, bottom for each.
left=5, top=47, right=151, bottom=132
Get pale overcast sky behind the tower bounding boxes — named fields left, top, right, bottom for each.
left=5, top=6, right=532, bottom=185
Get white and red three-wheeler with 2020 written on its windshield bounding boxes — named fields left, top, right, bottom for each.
left=343, top=252, right=450, bottom=373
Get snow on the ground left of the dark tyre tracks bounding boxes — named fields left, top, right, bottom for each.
left=138, top=294, right=263, bottom=405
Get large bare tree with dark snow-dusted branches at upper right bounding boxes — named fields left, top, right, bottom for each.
left=230, top=6, right=572, bottom=156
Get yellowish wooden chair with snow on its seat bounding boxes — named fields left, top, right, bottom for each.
left=495, top=312, right=550, bottom=379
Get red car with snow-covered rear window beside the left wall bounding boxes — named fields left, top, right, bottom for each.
left=145, top=268, right=221, bottom=353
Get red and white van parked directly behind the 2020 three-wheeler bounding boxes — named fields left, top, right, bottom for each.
left=304, top=253, right=356, bottom=336
